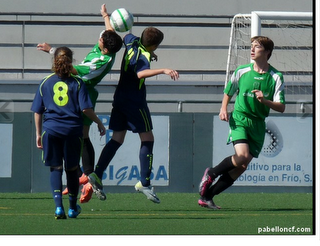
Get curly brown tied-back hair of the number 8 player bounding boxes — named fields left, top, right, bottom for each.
left=52, top=47, right=73, bottom=78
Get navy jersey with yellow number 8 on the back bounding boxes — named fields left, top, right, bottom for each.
left=31, top=74, right=92, bottom=136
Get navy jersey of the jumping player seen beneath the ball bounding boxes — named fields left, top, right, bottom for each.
left=114, top=34, right=150, bottom=106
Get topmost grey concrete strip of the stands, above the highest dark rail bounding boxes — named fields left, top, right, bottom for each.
left=0, top=0, right=313, bottom=15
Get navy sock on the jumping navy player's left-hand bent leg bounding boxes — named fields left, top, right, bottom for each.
left=94, top=139, right=121, bottom=179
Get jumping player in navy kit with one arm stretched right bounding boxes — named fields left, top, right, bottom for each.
left=89, top=27, right=179, bottom=203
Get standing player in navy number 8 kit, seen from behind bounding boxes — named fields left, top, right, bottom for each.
left=31, top=47, right=105, bottom=219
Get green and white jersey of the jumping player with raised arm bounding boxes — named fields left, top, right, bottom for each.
left=74, top=43, right=116, bottom=88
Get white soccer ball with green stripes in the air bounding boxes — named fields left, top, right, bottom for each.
left=110, top=8, right=133, bottom=32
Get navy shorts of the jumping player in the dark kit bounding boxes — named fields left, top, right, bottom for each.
left=109, top=106, right=153, bottom=133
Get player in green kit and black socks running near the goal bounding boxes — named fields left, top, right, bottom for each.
left=198, top=36, right=285, bottom=209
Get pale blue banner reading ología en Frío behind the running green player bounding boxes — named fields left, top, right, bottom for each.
left=213, top=116, right=313, bottom=186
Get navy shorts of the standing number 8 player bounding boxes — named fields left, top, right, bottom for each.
left=42, top=132, right=83, bottom=170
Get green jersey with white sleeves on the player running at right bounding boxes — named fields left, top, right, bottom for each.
left=224, top=63, right=285, bottom=120
